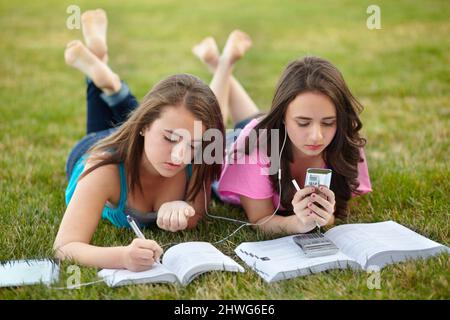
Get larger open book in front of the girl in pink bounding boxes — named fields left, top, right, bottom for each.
left=235, top=221, right=450, bottom=282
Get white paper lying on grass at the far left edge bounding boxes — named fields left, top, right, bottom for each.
left=0, top=259, right=59, bottom=287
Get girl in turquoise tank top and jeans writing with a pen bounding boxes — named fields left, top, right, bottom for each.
left=54, top=9, right=224, bottom=271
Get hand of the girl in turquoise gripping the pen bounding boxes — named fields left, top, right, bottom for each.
left=122, top=238, right=163, bottom=272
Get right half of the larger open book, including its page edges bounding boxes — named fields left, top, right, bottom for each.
left=325, top=221, right=448, bottom=269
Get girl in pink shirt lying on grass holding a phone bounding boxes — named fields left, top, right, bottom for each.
left=193, top=31, right=372, bottom=233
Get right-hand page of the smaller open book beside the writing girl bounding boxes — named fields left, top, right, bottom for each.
left=162, top=241, right=245, bottom=285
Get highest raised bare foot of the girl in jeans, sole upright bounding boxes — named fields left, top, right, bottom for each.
left=81, top=9, right=108, bottom=63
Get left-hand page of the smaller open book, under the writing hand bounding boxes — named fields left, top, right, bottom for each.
left=98, top=263, right=177, bottom=286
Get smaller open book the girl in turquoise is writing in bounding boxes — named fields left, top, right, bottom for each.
left=98, top=242, right=244, bottom=287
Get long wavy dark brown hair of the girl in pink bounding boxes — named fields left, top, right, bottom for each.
left=245, top=57, right=366, bottom=218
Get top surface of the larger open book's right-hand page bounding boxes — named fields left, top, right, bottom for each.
left=325, top=221, right=441, bottom=268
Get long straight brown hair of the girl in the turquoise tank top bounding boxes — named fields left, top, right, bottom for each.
left=79, top=74, right=225, bottom=201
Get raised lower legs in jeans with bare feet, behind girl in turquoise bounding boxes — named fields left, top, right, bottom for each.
left=64, top=9, right=138, bottom=133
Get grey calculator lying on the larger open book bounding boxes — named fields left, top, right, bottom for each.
left=293, top=233, right=339, bottom=258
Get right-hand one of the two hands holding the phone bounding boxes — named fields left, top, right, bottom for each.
left=308, top=186, right=336, bottom=227
